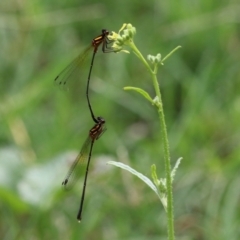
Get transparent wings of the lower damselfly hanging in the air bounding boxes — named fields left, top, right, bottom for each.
left=62, top=136, right=93, bottom=190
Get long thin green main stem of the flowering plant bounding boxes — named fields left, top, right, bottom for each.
left=129, top=42, right=175, bottom=240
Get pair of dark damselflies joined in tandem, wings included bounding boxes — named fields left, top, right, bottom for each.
left=54, top=29, right=114, bottom=222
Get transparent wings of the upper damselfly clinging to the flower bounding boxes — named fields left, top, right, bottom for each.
left=54, top=45, right=92, bottom=90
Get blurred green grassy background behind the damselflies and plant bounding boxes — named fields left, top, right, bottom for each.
left=0, top=0, right=240, bottom=240
